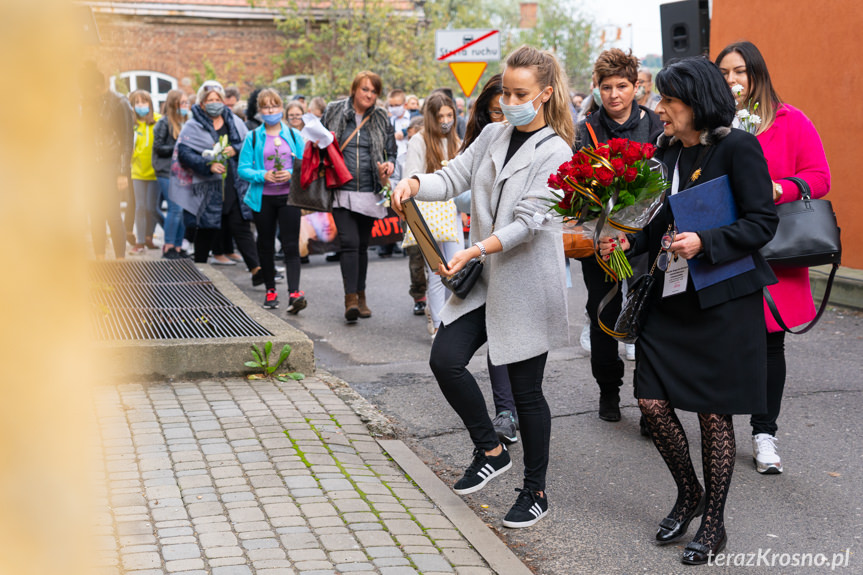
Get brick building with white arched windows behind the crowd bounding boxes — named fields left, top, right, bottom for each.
left=81, top=0, right=414, bottom=107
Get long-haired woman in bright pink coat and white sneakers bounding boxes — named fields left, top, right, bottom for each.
left=716, top=42, right=830, bottom=474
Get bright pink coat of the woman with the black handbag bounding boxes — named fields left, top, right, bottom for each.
left=758, top=104, right=830, bottom=332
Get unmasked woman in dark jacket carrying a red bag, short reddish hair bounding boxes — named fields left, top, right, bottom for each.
left=321, top=71, right=397, bottom=324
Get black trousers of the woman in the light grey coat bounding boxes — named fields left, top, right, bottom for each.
left=429, top=305, right=551, bottom=491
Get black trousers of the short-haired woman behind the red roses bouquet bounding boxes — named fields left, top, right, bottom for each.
left=579, top=258, right=623, bottom=393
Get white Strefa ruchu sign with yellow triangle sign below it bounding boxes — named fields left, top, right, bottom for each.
left=435, top=28, right=500, bottom=98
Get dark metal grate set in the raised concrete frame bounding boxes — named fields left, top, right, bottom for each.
left=90, top=260, right=273, bottom=340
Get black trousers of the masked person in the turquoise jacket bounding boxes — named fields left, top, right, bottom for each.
left=255, top=194, right=302, bottom=294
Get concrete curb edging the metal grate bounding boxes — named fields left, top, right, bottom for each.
left=96, top=264, right=315, bottom=382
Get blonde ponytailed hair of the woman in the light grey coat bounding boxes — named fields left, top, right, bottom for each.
left=505, top=45, right=575, bottom=146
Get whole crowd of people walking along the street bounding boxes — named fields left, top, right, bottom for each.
left=81, top=38, right=830, bottom=564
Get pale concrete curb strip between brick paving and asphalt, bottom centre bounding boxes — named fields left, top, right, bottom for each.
left=378, top=439, right=533, bottom=575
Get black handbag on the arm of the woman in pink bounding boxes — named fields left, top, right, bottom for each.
left=761, top=178, right=842, bottom=335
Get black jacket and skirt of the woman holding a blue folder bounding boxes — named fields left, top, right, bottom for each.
left=630, top=128, right=779, bottom=414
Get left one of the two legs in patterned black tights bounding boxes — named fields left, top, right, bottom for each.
left=638, top=399, right=704, bottom=521
